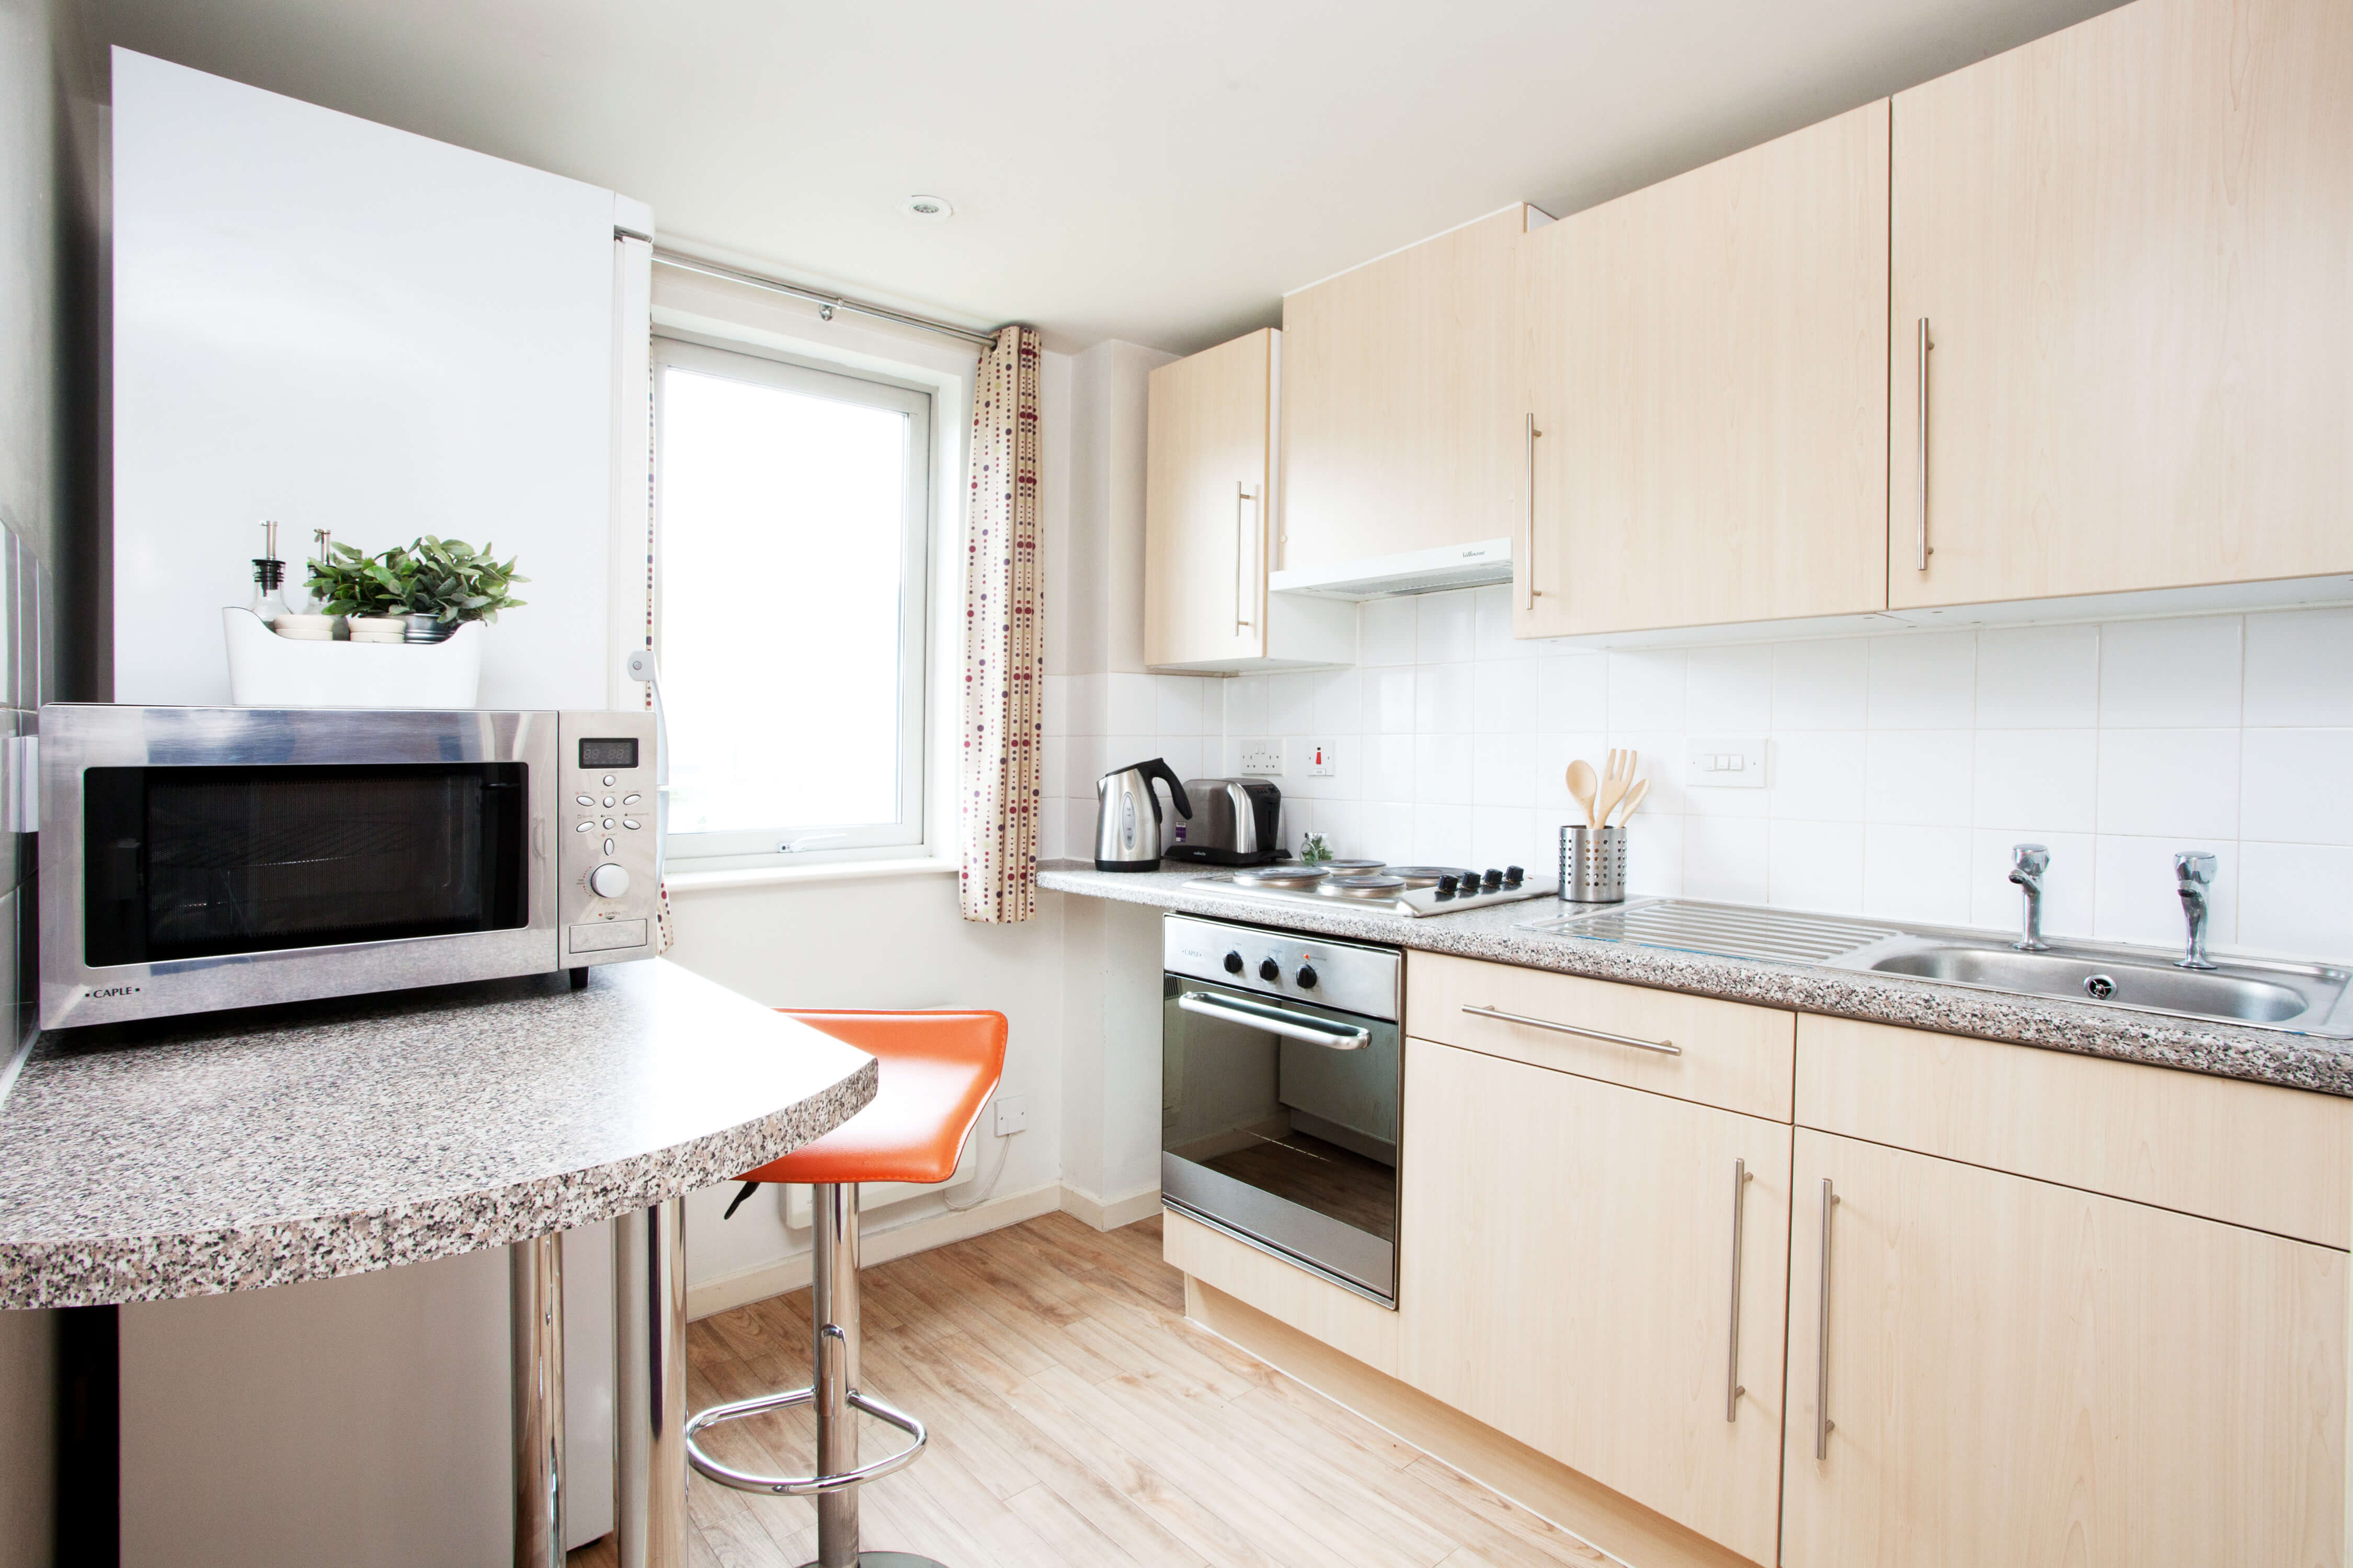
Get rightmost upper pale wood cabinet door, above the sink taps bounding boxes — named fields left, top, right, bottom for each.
left=1887, top=0, right=2353, bottom=608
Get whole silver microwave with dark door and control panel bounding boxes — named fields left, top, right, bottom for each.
left=40, top=704, right=661, bottom=1029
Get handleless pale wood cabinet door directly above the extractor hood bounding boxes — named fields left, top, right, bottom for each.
left=1275, top=205, right=1527, bottom=572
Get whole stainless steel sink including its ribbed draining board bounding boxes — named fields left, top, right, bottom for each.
left=1529, top=899, right=2353, bottom=1038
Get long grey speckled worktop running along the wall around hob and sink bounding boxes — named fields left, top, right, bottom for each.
left=1038, top=862, right=2353, bottom=1095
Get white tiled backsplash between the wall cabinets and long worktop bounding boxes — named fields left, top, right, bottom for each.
left=1045, top=589, right=2353, bottom=958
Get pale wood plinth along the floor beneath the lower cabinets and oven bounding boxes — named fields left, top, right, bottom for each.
left=1184, top=1274, right=1755, bottom=1568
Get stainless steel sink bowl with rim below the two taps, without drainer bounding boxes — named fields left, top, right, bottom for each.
left=1824, top=930, right=2353, bottom=1038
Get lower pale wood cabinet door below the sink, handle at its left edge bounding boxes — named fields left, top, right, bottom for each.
left=1781, top=1130, right=2346, bottom=1568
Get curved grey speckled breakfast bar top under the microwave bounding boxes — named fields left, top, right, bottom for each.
left=0, top=958, right=875, bottom=1307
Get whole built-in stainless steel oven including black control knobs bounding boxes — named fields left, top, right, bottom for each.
left=1160, top=913, right=1405, bottom=1307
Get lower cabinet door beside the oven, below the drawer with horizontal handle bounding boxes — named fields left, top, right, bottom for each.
left=1398, top=1038, right=1791, bottom=1563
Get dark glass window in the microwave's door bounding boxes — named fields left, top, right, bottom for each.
left=83, top=763, right=530, bottom=968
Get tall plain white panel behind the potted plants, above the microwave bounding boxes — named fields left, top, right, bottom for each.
left=113, top=50, right=614, bottom=708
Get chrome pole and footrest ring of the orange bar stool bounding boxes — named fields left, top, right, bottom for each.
left=687, top=1182, right=941, bottom=1568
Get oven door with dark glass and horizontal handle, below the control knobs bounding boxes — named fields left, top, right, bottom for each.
left=1160, top=975, right=1402, bottom=1307
